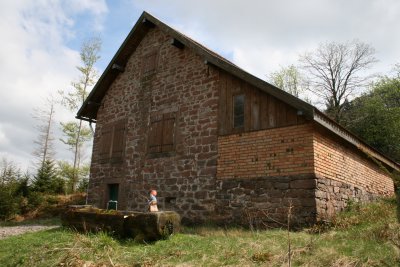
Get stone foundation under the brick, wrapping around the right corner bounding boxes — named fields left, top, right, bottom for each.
left=213, top=174, right=379, bottom=228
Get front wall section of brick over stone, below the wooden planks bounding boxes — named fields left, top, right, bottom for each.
left=214, top=124, right=316, bottom=227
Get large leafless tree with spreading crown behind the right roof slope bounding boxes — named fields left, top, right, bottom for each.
left=300, top=41, right=377, bottom=122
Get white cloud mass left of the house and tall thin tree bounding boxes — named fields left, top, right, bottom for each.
left=0, top=0, right=107, bottom=172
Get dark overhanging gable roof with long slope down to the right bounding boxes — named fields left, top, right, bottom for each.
left=77, top=12, right=400, bottom=170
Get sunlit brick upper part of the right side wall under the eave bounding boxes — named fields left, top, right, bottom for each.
left=314, top=131, right=394, bottom=196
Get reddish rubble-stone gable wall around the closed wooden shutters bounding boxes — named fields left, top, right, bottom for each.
left=89, top=28, right=218, bottom=223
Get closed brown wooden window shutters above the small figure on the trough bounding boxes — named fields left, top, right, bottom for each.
left=148, top=112, right=175, bottom=154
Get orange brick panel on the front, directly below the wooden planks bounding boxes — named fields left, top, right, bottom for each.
left=217, top=124, right=314, bottom=179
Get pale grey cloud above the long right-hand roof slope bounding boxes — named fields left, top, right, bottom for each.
left=133, top=0, right=400, bottom=76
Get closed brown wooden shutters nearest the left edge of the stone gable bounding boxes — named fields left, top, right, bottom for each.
left=99, top=119, right=126, bottom=163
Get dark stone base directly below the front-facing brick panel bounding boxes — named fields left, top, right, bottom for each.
left=215, top=174, right=316, bottom=228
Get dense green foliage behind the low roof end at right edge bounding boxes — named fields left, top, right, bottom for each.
left=342, top=72, right=400, bottom=162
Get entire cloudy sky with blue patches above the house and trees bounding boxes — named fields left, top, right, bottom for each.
left=0, top=0, right=400, bottom=172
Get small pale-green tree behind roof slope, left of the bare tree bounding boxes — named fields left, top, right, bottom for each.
left=269, top=65, right=304, bottom=97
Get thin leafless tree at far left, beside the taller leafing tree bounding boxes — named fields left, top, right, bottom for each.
left=32, top=96, right=56, bottom=168
